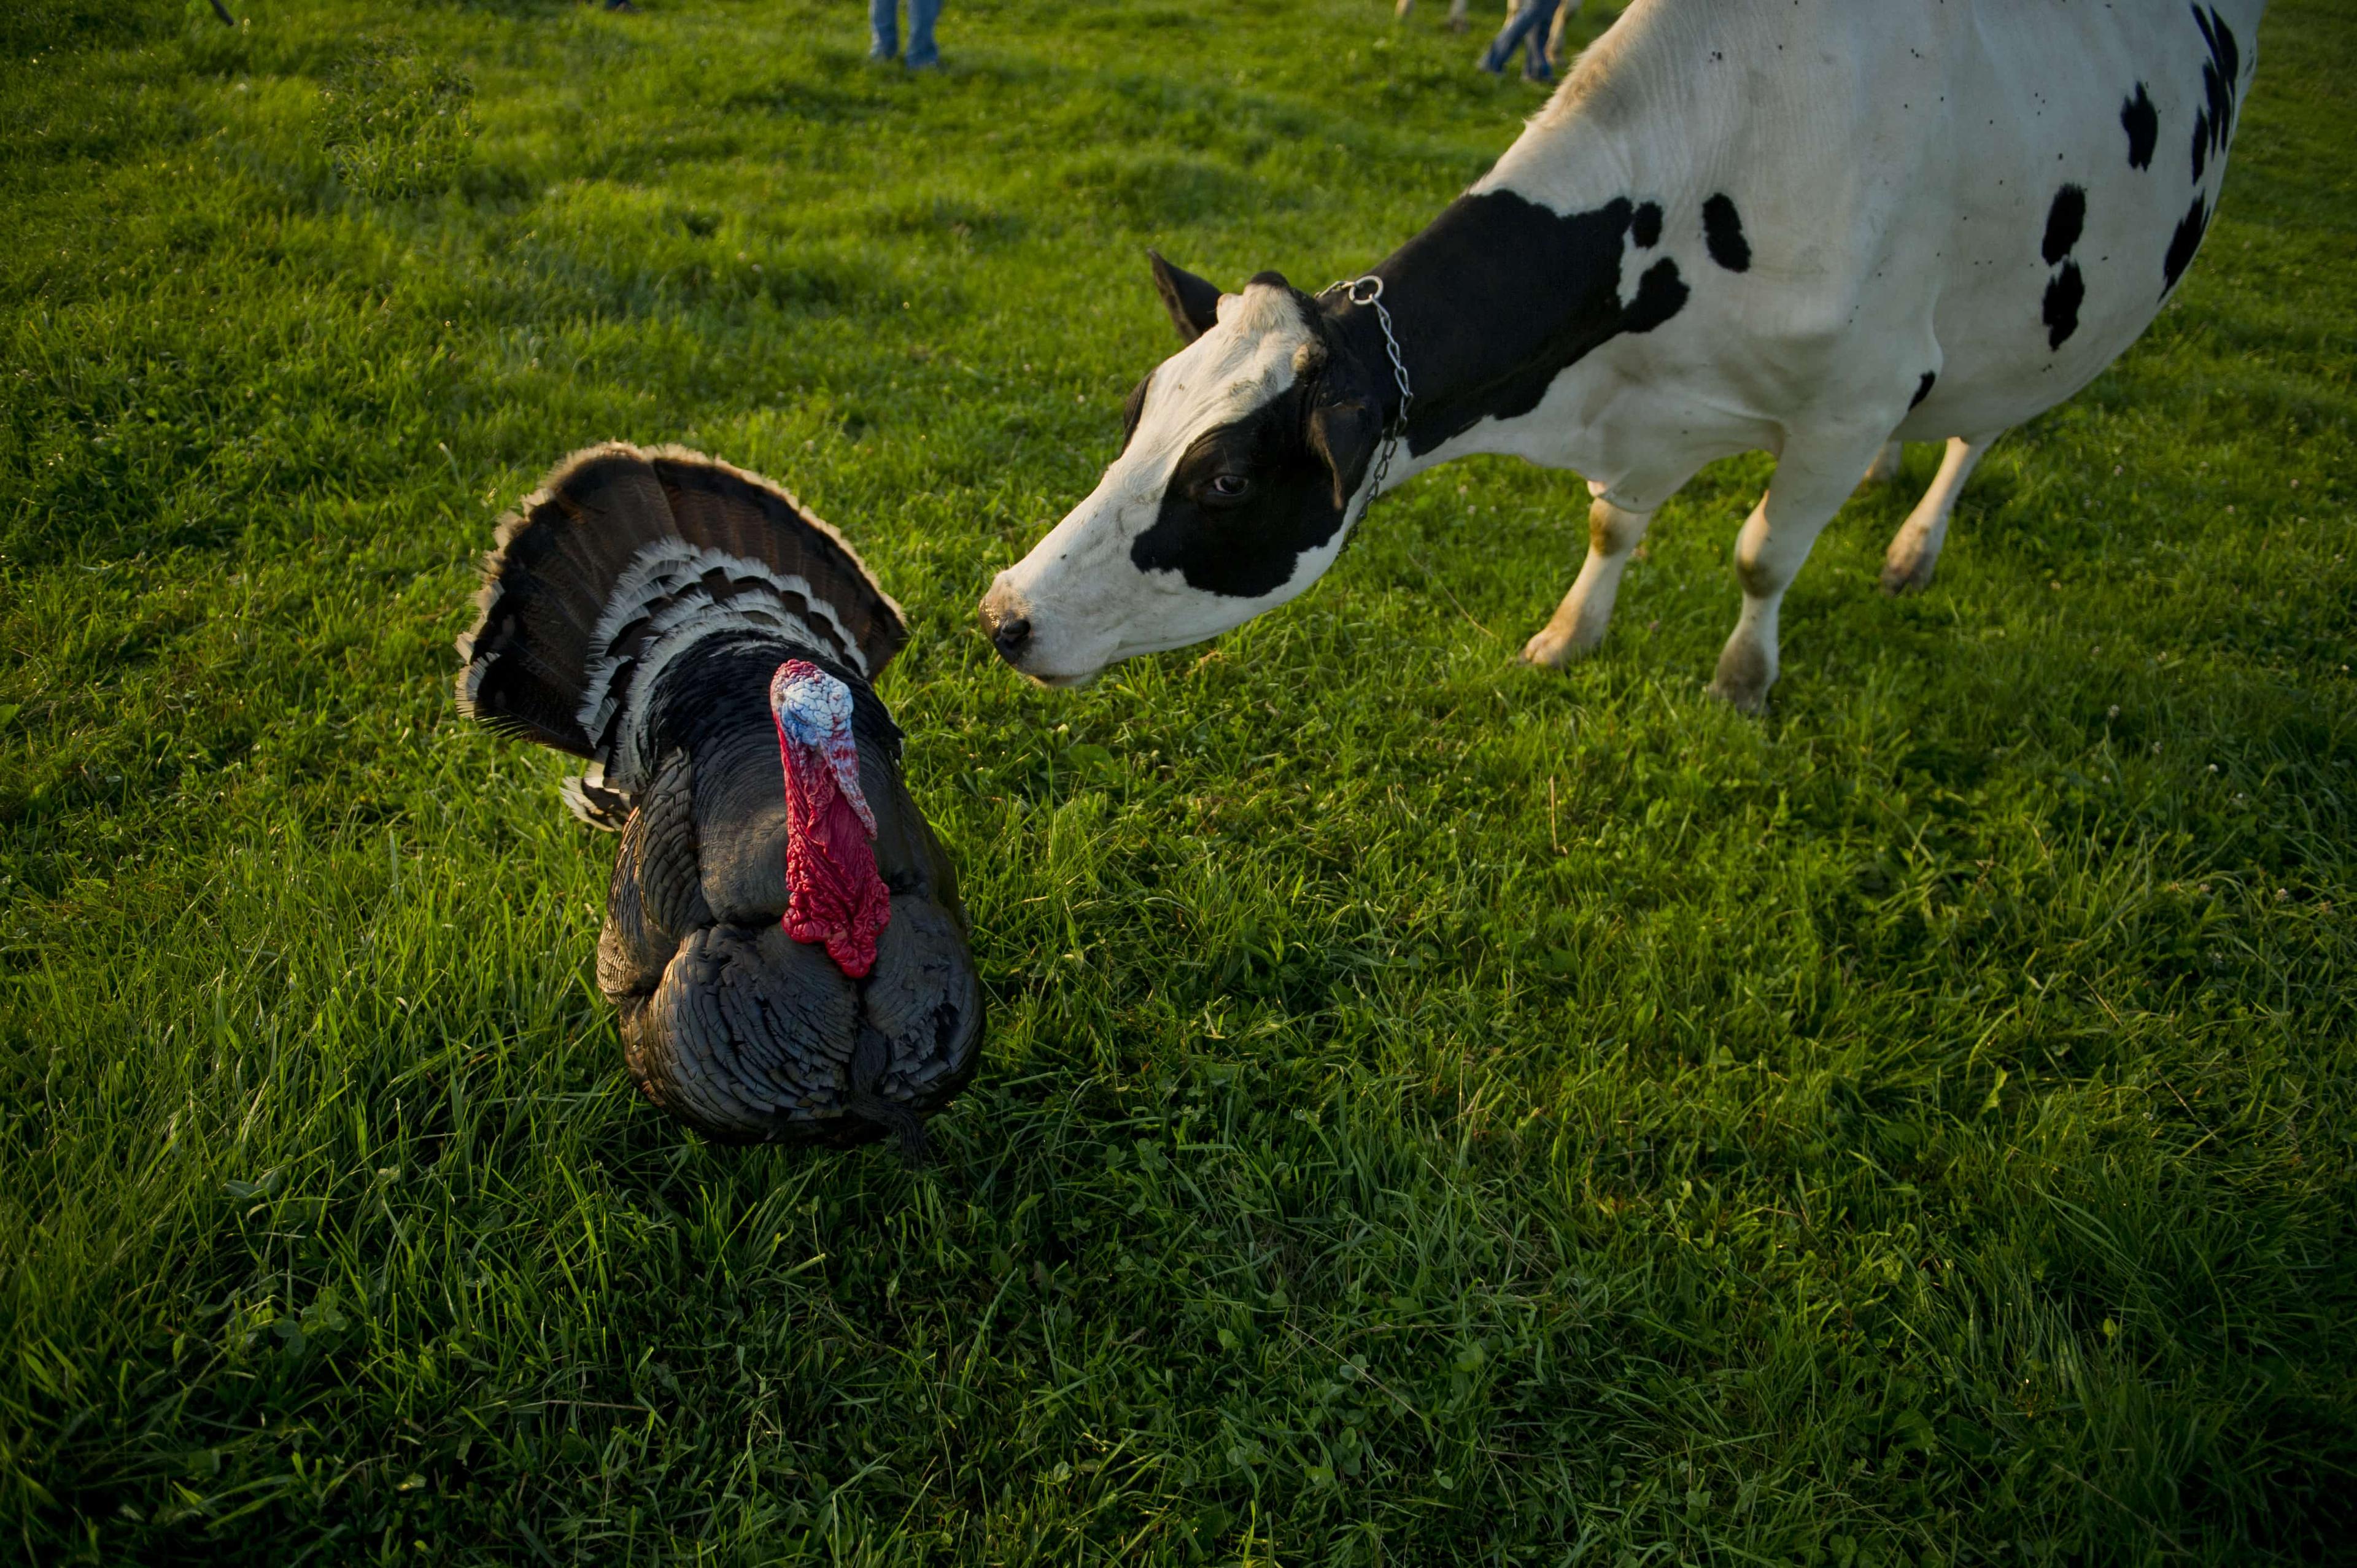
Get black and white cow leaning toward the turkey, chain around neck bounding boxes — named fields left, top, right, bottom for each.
left=983, top=0, right=2265, bottom=709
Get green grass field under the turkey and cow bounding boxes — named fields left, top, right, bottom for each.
left=0, top=0, right=2357, bottom=1568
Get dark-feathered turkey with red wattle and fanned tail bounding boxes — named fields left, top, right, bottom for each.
left=457, top=443, right=983, bottom=1157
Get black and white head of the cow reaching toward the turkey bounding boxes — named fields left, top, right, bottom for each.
left=980, top=255, right=1386, bottom=686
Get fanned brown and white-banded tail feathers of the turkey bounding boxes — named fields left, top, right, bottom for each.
left=457, top=441, right=907, bottom=828
